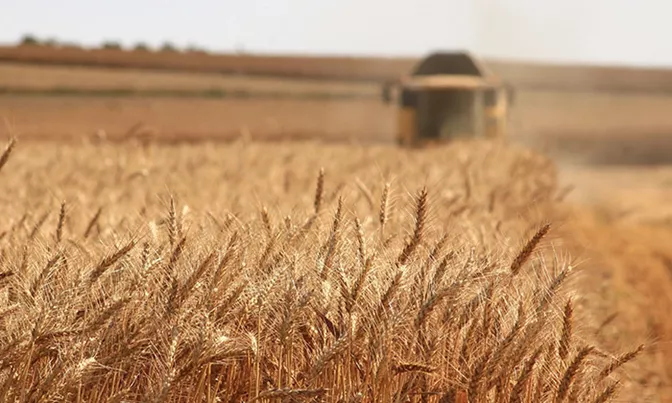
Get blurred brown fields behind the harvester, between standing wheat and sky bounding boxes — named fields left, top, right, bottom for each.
left=0, top=47, right=672, bottom=167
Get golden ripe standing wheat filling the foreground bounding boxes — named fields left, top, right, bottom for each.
left=0, top=137, right=645, bottom=402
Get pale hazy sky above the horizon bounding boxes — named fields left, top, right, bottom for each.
left=0, top=0, right=672, bottom=67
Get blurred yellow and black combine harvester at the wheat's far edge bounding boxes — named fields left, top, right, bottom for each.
left=382, top=52, right=511, bottom=145
